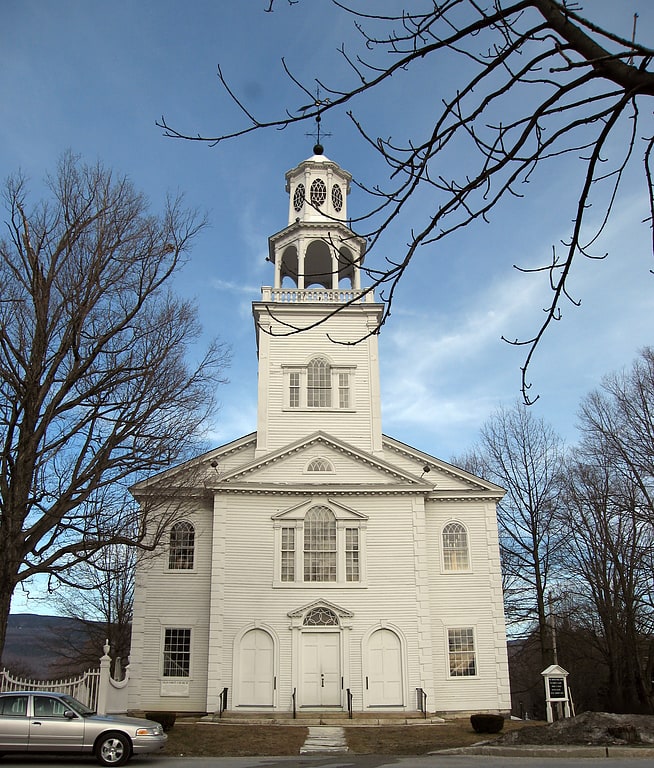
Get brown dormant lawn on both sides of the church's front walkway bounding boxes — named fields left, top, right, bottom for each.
left=164, top=719, right=542, bottom=757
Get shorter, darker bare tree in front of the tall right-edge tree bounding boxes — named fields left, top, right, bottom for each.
left=561, top=456, right=654, bottom=714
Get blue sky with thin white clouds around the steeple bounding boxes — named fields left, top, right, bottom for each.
left=5, top=0, right=654, bottom=612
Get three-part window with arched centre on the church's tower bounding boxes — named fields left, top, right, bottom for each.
left=282, top=356, right=354, bottom=411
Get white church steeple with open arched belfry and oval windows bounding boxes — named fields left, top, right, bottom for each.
left=253, top=152, right=383, bottom=456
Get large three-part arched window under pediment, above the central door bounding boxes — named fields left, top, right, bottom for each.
left=273, top=503, right=367, bottom=587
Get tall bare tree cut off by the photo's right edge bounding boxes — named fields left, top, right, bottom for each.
left=564, top=348, right=654, bottom=712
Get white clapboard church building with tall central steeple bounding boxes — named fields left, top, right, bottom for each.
left=129, top=146, right=510, bottom=715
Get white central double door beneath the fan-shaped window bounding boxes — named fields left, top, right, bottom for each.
left=300, top=632, right=342, bottom=707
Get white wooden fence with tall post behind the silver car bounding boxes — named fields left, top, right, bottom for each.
left=0, top=644, right=129, bottom=715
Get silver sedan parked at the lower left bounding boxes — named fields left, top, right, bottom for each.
left=0, top=691, right=168, bottom=766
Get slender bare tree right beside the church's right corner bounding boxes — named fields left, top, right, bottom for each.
left=454, top=403, right=564, bottom=669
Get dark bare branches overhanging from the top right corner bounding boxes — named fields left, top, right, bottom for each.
left=158, top=0, right=654, bottom=402
